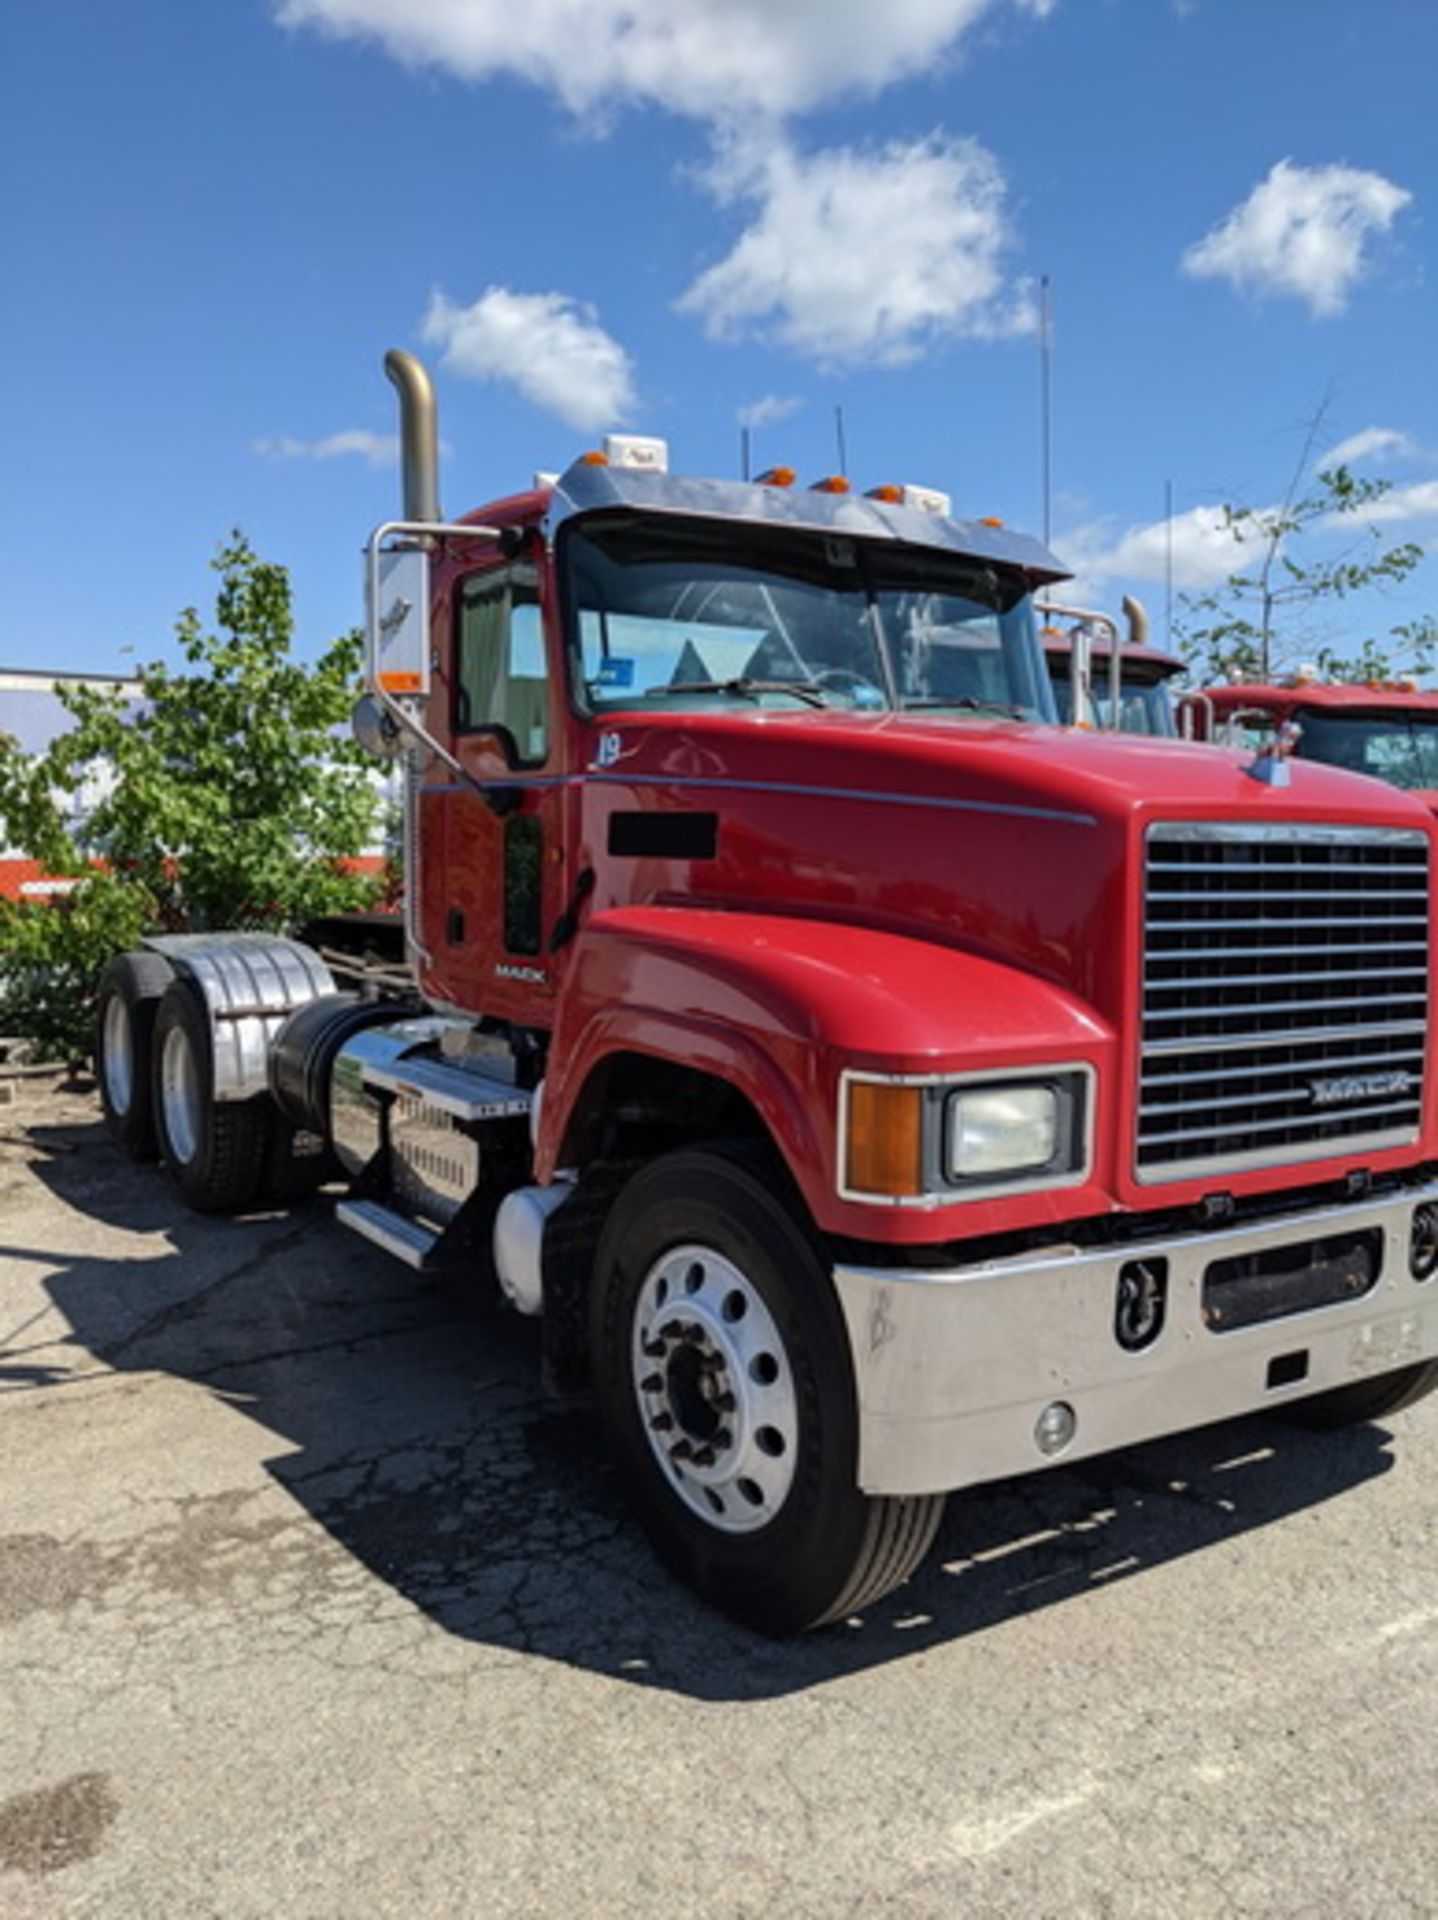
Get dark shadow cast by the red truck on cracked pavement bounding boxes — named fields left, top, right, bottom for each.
left=0, top=1123, right=1392, bottom=1701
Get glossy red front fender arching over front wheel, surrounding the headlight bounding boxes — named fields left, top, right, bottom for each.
left=536, top=906, right=1115, bottom=1244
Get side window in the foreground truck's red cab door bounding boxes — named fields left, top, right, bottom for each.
left=455, top=568, right=549, bottom=766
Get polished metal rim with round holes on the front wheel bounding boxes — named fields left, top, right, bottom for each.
left=630, top=1246, right=799, bottom=1534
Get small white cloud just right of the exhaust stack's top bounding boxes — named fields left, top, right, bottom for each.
left=422, top=286, right=635, bottom=432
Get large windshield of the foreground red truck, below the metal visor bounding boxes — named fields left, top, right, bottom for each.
left=563, top=515, right=1054, bottom=720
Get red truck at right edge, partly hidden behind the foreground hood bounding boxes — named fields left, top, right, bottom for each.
left=1179, top=672, right=1438, bottom=810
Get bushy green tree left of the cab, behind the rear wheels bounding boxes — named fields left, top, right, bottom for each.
left=0, top=534, right=378, bottom=1058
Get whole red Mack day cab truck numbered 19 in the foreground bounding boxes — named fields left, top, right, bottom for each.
left=98, top=353, right=1438, bottom=1632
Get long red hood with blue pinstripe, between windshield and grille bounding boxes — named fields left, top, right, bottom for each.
left=586, top=710, right=1432, bottom=1025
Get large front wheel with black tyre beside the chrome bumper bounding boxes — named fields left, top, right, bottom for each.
left=589, top=1148, right=943, bottom=1634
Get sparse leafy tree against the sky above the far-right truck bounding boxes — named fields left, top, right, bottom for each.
left=1173, top=467, right=1438, bottom=684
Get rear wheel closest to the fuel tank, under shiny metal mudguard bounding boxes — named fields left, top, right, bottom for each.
left=154, top=979, right=273, bottom=1213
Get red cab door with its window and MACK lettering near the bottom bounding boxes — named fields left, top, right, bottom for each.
left=428, top=561, right=564, bottom=1025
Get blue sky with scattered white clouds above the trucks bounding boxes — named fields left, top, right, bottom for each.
left=0, top=0, right=1438, bottom=672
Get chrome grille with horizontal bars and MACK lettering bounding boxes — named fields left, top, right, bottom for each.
left=1137, top=822, right=1428, bottom=1181
